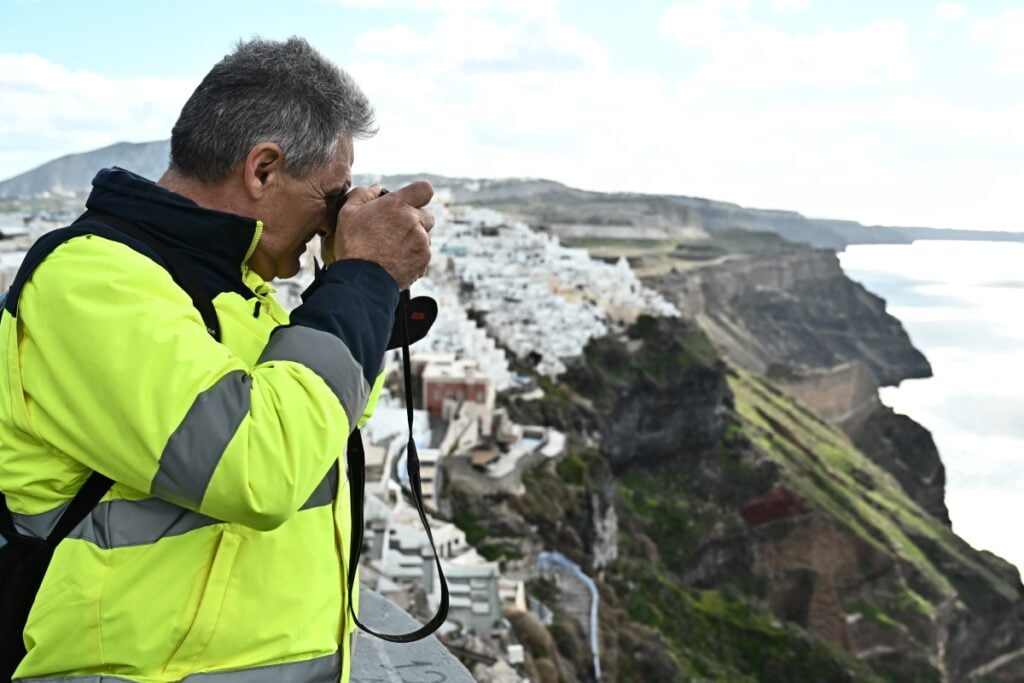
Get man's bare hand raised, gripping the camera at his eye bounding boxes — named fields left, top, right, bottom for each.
left=324, top=180, right=434, bottom=290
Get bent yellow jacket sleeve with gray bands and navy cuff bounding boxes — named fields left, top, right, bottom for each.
left=18, top=236, right=398, bottom=529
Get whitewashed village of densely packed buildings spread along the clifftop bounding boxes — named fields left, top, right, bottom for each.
left=0, top=190, right=679, bottom=683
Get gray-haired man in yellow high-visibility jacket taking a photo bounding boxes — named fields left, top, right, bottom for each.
left=0, top=38, right=433, bottom=683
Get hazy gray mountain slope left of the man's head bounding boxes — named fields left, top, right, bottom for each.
left=0, top=140, right=171, bottom=199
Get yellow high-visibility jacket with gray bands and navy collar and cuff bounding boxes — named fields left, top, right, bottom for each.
left=0, top=169, right=398, bottom=683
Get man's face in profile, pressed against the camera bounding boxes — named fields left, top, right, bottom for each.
left=252, top=136, right=353, bottom=280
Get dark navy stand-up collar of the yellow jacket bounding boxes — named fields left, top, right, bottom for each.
left=85, top=166, right=262, bottom=270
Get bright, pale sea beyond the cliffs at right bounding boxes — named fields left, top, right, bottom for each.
left=840, top=241, right=1024, bottom=568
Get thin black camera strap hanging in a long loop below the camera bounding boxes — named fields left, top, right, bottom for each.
left=347, top=290, right=449, bottom=643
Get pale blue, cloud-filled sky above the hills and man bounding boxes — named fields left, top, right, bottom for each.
left=0, top=0, right=1024, bottom=231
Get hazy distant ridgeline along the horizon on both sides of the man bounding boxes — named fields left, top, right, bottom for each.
left=0, top=140, right=1024, bottom=250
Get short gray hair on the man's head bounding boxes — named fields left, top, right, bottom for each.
left=171, top=37, right=377, bottom=182
